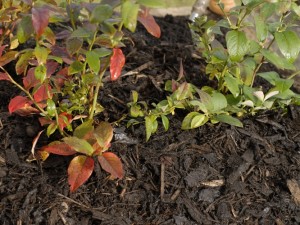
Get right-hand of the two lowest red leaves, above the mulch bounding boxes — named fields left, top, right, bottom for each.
left=98, top=152, right=124, bottom=179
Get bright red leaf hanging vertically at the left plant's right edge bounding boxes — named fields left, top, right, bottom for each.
left=110, top=48, right=125, bottom=80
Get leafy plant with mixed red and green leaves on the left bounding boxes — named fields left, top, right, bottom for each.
left=0, top=0, right=161, bottom=191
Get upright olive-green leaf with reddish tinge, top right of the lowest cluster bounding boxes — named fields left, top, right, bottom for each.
left=94, top=122, right=113, bottom=150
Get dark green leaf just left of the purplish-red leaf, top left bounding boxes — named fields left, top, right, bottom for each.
left=17, top=16, right=34, bottom=44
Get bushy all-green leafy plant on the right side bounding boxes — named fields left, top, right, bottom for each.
left=128, top=0, right=300, bottom=140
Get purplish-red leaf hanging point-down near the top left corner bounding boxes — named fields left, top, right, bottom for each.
left=31, top=8, right=49, bottom=38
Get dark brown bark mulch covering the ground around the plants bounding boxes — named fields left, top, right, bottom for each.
left=0, top=16, right=300, bottom=225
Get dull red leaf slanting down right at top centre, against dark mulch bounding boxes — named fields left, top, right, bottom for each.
left=138, top=8, right=161, bottom=38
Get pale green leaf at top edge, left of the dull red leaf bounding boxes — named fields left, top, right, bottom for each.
left=121, top=1, right=139, bottom=32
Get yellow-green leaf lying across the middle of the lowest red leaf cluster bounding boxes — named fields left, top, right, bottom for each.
left=63, top=137, right=94, bottom=156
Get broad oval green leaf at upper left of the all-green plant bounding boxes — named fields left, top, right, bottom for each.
left=226, top=30, right=249, bottom=62
